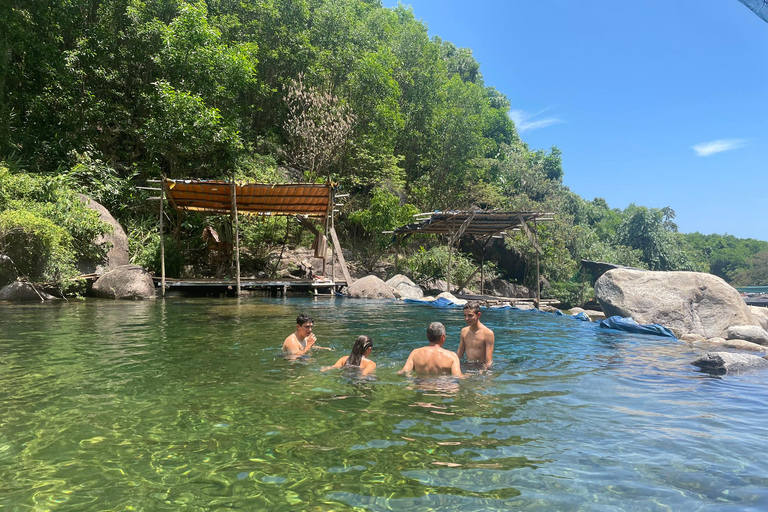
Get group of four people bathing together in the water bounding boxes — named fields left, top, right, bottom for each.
left=283, top=301, right=495, bottom=377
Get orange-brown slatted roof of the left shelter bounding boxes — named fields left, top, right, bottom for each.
left=162, top=179, right=333, bottom=217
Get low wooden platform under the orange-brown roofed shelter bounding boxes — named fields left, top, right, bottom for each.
left=152, top=277, right=347, bottom=297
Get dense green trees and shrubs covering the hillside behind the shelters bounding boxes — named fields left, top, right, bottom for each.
left=0, top=0, right=768, bottom=300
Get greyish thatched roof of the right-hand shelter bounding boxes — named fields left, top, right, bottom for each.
left=394, top=211, right=554, bottom=237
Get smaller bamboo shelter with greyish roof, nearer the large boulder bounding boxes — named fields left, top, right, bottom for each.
left=393, top=210, right=554, bottom=301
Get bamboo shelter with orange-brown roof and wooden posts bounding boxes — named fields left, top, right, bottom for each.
left=151, top=179, right=351, bottom=294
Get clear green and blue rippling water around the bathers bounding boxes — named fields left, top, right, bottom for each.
left=0, top=299, right=768, bottom=512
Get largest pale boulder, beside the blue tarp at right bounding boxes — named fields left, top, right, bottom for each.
left=595, top=268, right=757, bottom=338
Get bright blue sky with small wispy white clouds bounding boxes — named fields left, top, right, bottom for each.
left=384, top=0, right=768, bottom=240
